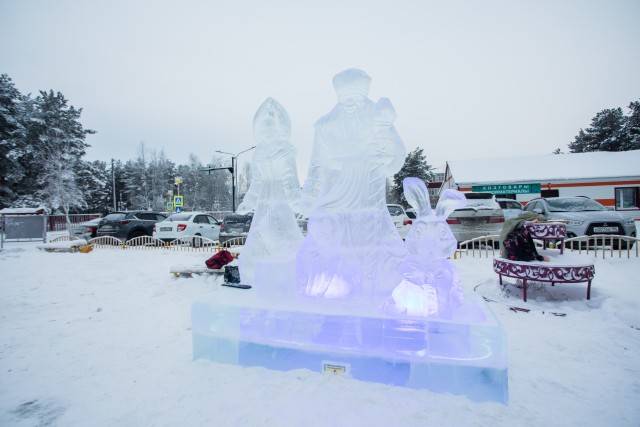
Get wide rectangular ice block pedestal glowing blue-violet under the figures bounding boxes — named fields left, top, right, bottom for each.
left=192, top=289, right=508, bottom=403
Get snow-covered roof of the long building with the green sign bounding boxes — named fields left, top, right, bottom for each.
left=447, top=150, right=640, bottom=184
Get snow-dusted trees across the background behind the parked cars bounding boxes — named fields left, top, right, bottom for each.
left=0, top=74, right=640, bottom=213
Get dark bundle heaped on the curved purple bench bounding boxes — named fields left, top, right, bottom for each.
left=500, top=212, right=549, bottom=261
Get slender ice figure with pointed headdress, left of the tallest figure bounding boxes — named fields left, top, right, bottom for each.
left=238, top=98, right=303, bottom=295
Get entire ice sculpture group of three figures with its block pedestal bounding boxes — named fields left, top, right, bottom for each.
left=191, top=69, right=508, bottom=402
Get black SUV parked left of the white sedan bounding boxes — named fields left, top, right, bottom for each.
left=96, top=211, right=167, bottom=240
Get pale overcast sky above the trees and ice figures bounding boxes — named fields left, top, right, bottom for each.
left=0, top=0, right=640, bottom=179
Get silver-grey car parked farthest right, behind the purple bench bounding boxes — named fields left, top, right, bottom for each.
left=524, top=196, right=636, bottom=247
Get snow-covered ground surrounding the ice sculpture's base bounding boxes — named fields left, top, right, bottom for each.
left=0, top=239, right=640, bottom=427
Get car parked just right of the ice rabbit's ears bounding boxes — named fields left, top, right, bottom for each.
left=447, top=193, right=504, bottom=243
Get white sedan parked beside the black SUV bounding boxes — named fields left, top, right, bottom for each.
left=153, top=212, right=220, bottom=246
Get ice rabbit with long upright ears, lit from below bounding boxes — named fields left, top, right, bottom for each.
left=386, top=178, right=467, bottom=319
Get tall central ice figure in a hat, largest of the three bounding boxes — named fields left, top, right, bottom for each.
left=296, top=69, right=406, bottom=300
